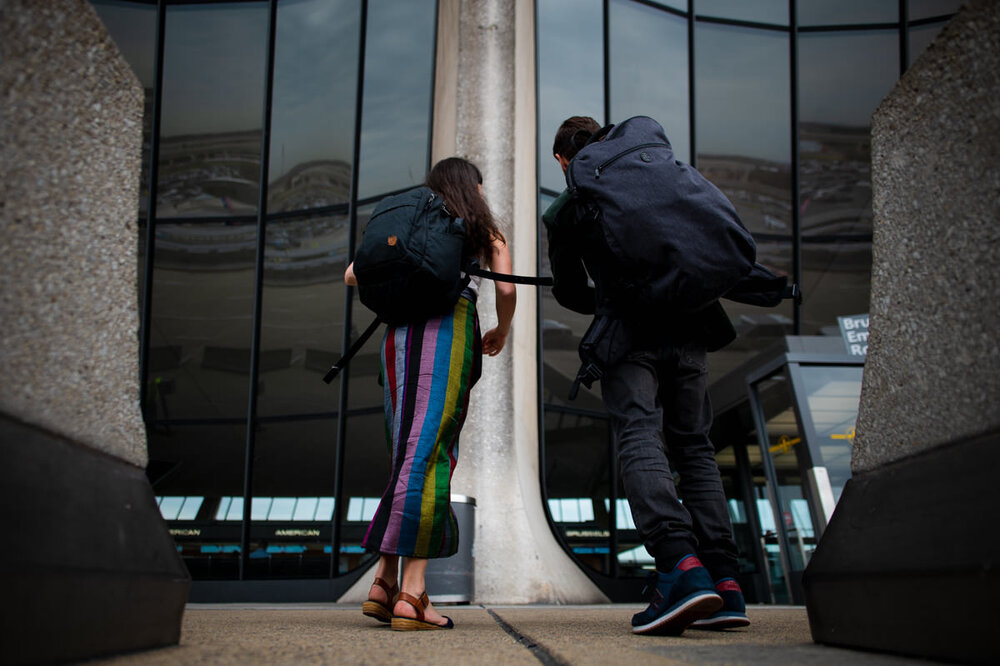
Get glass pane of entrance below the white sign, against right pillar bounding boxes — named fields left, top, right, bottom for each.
left=801, top=366, right=864, bottom=500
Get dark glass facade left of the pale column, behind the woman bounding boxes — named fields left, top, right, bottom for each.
left=93, top=0, right=436, bottom=580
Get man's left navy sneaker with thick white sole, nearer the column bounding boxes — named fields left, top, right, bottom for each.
left=632, top=555, right=722, bottom=636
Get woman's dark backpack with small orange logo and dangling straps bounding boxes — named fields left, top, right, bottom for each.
left=323, top=186, right=552, bottom=384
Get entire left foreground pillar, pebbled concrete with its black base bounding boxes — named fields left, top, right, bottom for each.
left=0, top=0, right=189, bottom=663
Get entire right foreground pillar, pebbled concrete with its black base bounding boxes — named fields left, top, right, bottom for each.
left=804, top=0, right=1000, bottom=663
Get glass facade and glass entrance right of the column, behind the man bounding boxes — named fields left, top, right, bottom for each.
left=536, top=0, right=957, bottom=603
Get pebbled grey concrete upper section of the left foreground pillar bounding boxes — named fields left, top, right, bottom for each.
left=0, top=0, right=146, bottom=466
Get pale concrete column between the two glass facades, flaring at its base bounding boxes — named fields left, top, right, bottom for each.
left=433, top=0, right=607, bottom=603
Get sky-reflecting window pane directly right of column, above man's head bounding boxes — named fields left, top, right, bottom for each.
left=536, top=0, right=606, bottom=192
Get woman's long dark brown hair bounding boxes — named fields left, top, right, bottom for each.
left=425, top=157, right=507, bottom=263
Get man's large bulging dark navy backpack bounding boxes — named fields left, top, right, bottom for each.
left=566, top=116, right=757, bottom=313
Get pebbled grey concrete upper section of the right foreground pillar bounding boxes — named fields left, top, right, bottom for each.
left=852, top=0, right=1000, bottom=472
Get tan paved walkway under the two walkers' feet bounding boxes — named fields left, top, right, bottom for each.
left=88, top=604, right=929, bottom=666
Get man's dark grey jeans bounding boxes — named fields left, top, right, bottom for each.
left=601, top=345, right=737, bottom=580
